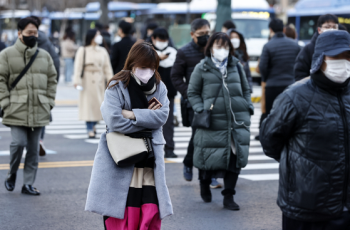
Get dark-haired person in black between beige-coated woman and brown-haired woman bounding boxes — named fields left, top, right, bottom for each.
left=111, top=20, right=135, bottom=74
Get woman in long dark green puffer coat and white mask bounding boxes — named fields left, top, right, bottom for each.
left=187, top=32, right=254, bottom=210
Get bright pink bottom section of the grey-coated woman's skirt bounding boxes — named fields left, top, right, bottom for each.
left=105, top=204, right=161, bottom=230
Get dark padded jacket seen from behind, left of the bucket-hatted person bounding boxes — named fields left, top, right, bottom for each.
left=259, top=33, right=300, bottom=87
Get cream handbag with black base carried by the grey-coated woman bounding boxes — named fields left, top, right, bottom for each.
left=106, top=132, right=149, bottom=167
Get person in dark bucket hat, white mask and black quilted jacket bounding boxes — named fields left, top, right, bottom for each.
left=260, top=31, right=350, bottom=230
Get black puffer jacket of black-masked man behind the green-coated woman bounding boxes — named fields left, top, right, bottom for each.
left=171, top=40, right=204, bottom=98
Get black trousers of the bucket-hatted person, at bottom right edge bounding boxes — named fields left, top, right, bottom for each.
left=282, top=212, right=350, bottom=230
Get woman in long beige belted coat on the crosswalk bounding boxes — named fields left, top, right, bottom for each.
left=73, top=29, right=113, bottom=138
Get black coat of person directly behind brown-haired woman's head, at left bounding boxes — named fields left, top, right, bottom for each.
left=111, top=36, right=135, bottom=74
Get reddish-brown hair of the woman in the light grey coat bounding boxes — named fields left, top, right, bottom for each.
left=108, top=42, right=161, bottom=89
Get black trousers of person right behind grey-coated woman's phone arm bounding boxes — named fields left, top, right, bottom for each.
left=163, top=98, right=175, bottom=151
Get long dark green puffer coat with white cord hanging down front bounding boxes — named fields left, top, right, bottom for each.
left=187, top=57, right=254, bottom=170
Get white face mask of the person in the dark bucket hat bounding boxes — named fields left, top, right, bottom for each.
left=322, top=59, right=350, bottom=84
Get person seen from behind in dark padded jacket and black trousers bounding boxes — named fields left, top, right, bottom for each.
left=259, top=19, right=300, bottom=116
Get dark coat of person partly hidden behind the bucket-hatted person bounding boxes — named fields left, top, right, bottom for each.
left=294, top=31, right=319, bottom=81
